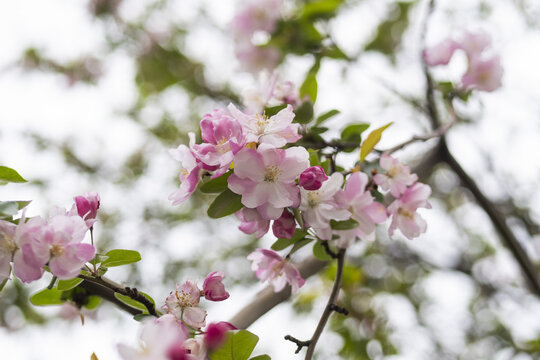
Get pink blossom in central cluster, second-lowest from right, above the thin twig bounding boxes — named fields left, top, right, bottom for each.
left=336, top=172, right=388, bottom=244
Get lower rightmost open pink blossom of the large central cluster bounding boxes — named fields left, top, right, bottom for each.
left=388, top=183, right=431, bottom=239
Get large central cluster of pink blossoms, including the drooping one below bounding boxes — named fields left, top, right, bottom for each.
left=169, top=92, right=431, bottom=291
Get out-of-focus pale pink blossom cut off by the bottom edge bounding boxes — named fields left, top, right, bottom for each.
left=118, top=314, right=189, bottom=360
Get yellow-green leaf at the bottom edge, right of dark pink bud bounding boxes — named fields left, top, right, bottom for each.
left=210, top=330, right=259, bottom=360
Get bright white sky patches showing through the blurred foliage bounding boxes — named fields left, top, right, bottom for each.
left=0, top=0, right=540, bottom=360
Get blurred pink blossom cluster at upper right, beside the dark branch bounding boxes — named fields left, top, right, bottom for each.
left=423, top=32, right=503, bottom=92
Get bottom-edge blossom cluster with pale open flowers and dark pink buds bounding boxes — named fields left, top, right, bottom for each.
left=118, top=271, right=236, bottom=360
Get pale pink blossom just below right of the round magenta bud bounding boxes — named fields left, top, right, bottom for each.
left=299, top=173, right=351, bottom=240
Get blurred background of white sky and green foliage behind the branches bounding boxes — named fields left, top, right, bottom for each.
left=0, top=0, right=540, bottom=360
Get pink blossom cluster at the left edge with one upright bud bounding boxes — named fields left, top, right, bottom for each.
left=0, top=193, right=99, bottom=283
